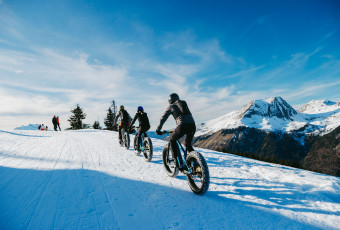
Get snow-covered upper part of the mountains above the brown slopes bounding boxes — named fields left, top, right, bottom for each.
left=196, top=97, right=340, bottom=136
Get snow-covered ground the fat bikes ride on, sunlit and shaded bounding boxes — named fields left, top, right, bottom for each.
left=0, top=130, right=340, bottom=230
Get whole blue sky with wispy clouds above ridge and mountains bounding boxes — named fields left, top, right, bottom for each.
left=0, top=0, right=340, bottom=128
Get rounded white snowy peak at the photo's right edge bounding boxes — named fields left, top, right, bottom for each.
left=299, top=100, right=340, bottom=114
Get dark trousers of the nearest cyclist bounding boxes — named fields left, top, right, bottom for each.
left=170, top=123, right=196, bottom=164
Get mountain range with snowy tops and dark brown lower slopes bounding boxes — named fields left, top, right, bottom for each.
left=194, top=97, right=340, bottom=175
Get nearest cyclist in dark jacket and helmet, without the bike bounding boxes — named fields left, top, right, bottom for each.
left=156, top=93, right=196, bottom=170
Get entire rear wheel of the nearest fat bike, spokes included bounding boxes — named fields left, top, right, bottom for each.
left=186, top=151, right=210, bottom=195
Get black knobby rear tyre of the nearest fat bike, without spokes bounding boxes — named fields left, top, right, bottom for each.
left=186, top=151, right=210, bottom=195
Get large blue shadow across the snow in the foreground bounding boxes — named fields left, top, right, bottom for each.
left=0, top=167, right=322, bottom=229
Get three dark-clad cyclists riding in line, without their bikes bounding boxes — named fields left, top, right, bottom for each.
left=114, top=93, right=196, bottom=171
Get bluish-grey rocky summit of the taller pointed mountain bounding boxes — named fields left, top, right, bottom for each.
left=243, top=97, right=297, bottom=120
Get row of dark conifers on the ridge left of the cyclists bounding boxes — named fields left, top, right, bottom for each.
left=68, top=100, right=117, bottom=131
